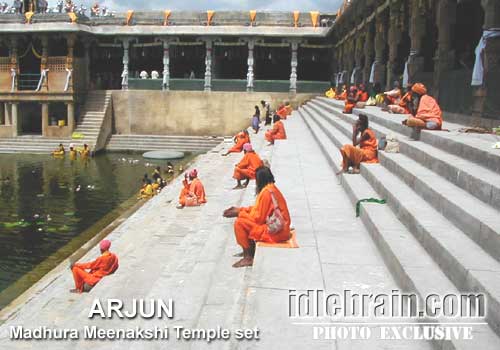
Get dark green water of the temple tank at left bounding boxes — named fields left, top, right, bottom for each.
left=0, top=153, right=194, bottom=308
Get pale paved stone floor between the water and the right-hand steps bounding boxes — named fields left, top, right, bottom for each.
left=0, top=115, right=430, bottom=350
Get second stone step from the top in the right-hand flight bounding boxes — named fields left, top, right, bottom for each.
left=310, top=99, right=500, bottom=210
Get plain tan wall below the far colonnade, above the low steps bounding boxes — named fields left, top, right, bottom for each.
left=112, top=90, right=314, bottom=136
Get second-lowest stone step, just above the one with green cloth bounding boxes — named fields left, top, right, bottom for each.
left=302, top=106, right=500, bottom=340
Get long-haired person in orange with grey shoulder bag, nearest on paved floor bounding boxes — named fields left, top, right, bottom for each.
left=222, top=166, right=291, bottom=267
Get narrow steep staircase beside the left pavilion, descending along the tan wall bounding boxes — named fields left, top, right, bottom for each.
left=73, top=90, right=111, bottom=150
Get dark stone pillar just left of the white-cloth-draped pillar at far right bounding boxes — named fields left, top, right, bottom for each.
left=433, top=0, right=457, bottom=98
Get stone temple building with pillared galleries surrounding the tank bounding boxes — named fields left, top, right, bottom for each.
left=0, top=0, right=500, bottom=150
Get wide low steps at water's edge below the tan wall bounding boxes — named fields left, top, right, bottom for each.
left=106, top=135, right=224, bottom=152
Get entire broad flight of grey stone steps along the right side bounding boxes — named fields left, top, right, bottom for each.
left=299, top=98, right=500, bottom=349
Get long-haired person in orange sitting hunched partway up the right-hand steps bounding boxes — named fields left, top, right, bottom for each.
left=337, top=114, right=378, bottom=175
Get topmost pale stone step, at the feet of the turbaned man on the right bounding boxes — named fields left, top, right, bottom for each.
left=318, top=97, right=500, bottom=172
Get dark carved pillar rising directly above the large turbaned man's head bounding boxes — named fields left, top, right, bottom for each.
left=408, top=0, right=426, bottom=83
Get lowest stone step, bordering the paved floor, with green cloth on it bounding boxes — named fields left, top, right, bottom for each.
left=300, top=108, right=500, bottom=350
